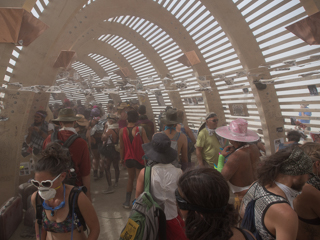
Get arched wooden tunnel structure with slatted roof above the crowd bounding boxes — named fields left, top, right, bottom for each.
left=0, top=0, right=320, bottom=205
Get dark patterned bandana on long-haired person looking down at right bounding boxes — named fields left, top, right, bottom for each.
left=280, top=148, right=312, bottom=176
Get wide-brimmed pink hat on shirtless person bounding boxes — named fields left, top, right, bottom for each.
left=216, top=118, right=260, bottom=142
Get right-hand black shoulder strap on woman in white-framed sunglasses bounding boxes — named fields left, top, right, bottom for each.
left=69, top=186, right=87, bottom=231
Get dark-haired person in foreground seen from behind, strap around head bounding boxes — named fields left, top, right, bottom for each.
left=175, top=167, right=255, bottom=240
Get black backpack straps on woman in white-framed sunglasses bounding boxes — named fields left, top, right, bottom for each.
left=36, top=186, right=87, bottom=240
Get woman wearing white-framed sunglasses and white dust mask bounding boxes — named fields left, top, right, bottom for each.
left=31, top=142, right=100, bottom=240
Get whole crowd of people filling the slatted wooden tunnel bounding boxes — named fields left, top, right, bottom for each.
left=26, top=100, right=320, bottom=240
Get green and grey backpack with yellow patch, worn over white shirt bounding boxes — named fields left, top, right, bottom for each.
left=119, top=166, right=166, bottom=240
